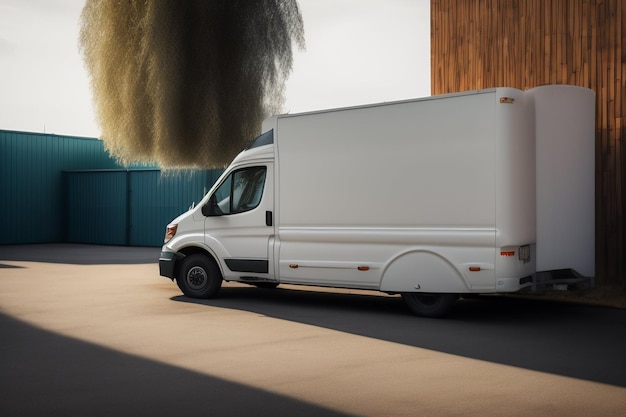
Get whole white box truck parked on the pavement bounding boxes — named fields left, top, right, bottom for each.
left=159, top=85, right=595, bottom=316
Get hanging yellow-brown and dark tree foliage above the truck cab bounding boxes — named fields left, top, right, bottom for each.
left=79, top=0, right=304, bottom=168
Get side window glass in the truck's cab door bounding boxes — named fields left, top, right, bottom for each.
left=214, top=166, right=267, bottom=215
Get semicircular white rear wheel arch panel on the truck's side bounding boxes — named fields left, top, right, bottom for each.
left=380, top=248, right=471, bottom=293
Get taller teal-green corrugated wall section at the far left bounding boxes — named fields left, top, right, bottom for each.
left=0, top=130, right=119, bottom=244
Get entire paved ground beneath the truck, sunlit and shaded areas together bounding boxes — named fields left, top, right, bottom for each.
left=0, top=245, right=626, bottom=416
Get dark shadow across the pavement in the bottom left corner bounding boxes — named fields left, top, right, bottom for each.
left=0, top=314, right=356, bottom=417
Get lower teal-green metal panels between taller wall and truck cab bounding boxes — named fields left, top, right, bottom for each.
left=64, top=169, right=222, bottom=246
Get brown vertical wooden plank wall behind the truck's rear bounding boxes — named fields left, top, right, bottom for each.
left=431, top=0, right=626, bottom=290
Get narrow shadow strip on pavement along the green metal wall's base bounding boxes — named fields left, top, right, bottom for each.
left=0, top=243, right=161, bottom=268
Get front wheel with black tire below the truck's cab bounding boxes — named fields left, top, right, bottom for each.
left=176, top=254, right=222, bottom=298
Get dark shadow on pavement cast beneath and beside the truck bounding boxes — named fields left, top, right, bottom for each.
left=173, top=287, right=626, bottom=387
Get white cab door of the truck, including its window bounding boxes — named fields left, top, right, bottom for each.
left=202, top=162, right=275, bottom=282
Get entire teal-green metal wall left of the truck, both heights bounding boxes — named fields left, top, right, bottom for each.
left=0, top=130, right=222, bottom=246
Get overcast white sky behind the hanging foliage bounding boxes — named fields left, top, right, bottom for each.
left=0, top=0, right=430, bottom=137
